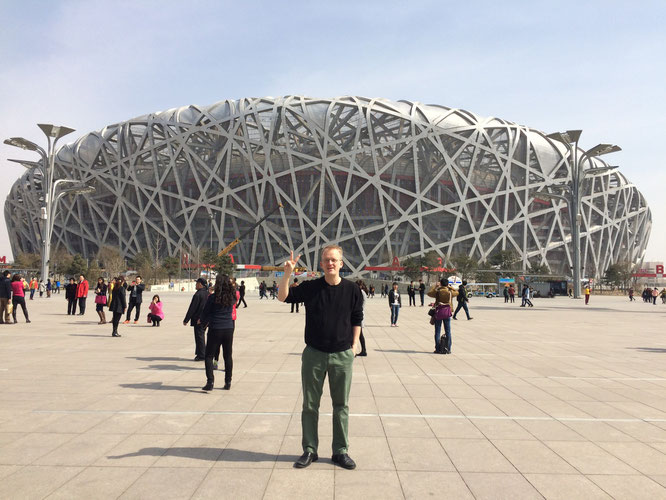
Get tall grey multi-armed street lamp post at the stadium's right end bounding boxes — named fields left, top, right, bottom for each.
left=534, top=130, right=622, bottom=299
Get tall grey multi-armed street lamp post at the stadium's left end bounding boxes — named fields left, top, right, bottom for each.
left=4, top=123, right=95, bottom=280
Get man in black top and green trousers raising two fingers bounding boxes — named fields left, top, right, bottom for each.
left=278, top=245, right=363, bottom=469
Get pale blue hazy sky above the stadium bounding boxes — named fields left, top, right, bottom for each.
left=0, top=0, right=666, bottom=260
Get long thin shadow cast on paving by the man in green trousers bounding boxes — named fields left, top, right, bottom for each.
left=107, top=448, right=298, bottom=462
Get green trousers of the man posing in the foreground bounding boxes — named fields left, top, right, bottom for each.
left=301, top=346, right=354, bottom=455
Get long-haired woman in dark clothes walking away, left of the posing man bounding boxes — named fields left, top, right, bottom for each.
left=199, top=274, right=237, bottom=392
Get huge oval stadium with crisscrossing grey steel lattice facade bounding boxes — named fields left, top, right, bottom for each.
left=5, top=96, right=651, bottom=277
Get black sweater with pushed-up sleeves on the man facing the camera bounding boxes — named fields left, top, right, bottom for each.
left=285, top=278, right=363, bottom=352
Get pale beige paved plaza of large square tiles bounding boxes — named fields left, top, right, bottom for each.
left=0, top=292, right=666, bottom=500
